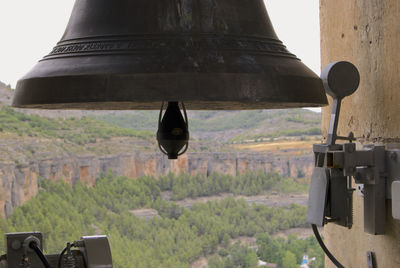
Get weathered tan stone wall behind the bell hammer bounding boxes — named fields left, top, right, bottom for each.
left=320, top=0, right=400, bottom=268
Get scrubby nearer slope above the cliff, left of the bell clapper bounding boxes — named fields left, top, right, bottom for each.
left=0, top=105, right=156, bottom=161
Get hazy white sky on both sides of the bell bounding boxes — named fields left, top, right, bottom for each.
left=0, top=0, right=320, bottom=86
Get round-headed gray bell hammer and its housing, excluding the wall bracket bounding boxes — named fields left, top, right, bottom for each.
left=307, top=61, right=360, bottom=228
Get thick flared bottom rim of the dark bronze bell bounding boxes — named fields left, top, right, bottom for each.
left=12, top=70, right=328, bottom=110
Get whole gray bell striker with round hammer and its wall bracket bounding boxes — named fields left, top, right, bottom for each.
left=307, top=61, right=400, bottom=235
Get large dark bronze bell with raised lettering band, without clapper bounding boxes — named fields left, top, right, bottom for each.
left=13, top=0, right=327, bottom=109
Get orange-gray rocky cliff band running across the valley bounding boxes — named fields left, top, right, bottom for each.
left=0, top=153, right=313, bottom=217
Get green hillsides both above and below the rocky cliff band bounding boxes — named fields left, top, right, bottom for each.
left=0, top=82, right=323, bottom=268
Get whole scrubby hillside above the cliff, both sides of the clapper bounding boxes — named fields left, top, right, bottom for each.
left=0, top=105, right=320, bottom=163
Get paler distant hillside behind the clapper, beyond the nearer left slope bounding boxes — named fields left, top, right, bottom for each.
left=93, top=109, right=321, bottom=142
